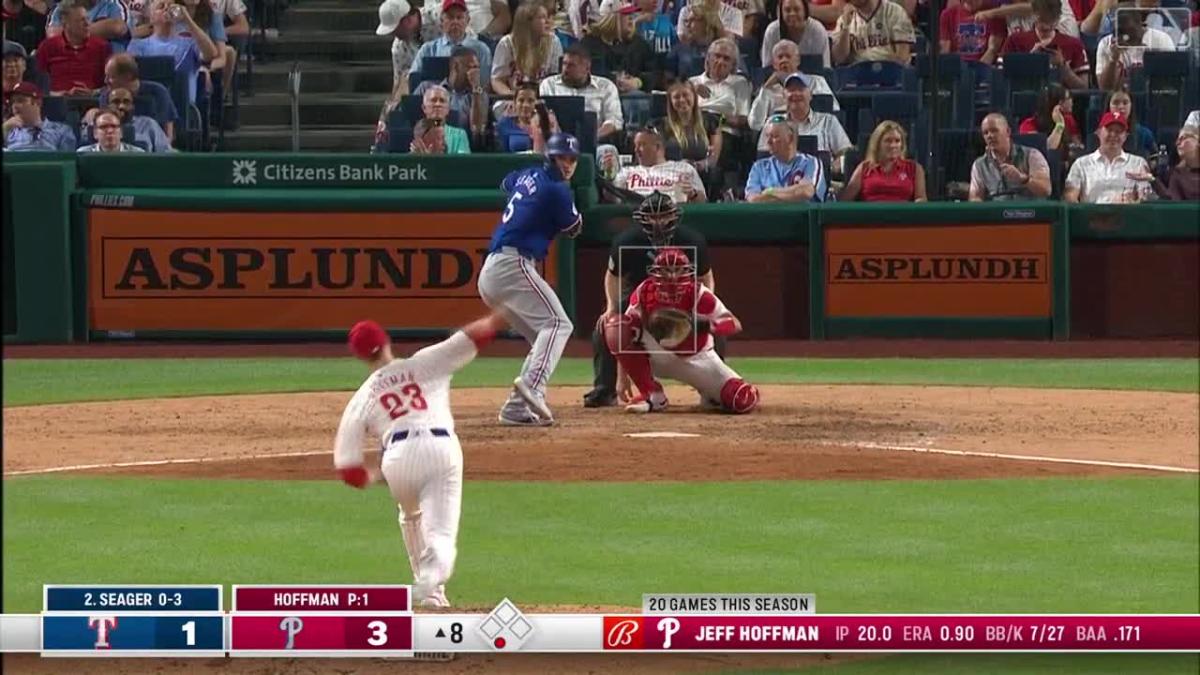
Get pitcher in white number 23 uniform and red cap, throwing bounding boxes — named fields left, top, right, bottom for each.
left=334, top=315, right=504, bottom=608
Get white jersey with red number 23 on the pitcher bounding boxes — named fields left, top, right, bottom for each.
left=334, top=330, right=476, bottom=468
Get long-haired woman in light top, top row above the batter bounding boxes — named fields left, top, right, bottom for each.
left=492, top=0, right=563, bottom=96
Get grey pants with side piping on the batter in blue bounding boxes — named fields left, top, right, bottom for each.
left=479, top=249, right=575, bottom=410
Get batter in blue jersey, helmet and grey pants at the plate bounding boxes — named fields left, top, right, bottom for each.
left=479, top=133, right=583, bottom=426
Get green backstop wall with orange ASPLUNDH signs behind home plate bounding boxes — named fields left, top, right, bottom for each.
left=4, top=154, right=1200, bottom=342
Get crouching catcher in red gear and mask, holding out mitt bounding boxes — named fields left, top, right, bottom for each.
left=605, top=247, right=758, bottom=414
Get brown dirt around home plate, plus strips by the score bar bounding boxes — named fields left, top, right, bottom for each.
left=4, top=386, right=1200, bottom=674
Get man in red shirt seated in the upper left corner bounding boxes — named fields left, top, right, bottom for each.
left=37, top=0, right=113, bottom=96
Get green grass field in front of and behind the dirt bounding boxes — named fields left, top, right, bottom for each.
left=2, top=359, right=1200, bottom=675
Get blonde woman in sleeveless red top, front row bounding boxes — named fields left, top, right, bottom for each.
left=841, top=120, right=926, bottom=202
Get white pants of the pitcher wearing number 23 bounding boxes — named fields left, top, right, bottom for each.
left=382, top=430, right=462, bottom=586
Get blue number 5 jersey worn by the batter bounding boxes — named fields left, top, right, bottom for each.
left=488, top=167, right=581, bottom=261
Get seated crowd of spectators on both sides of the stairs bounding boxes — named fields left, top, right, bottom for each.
left=2, top=0, right=1200, bottom=203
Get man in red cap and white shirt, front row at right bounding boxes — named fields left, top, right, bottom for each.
left=1062, top=110, right=1151, bottom=204
